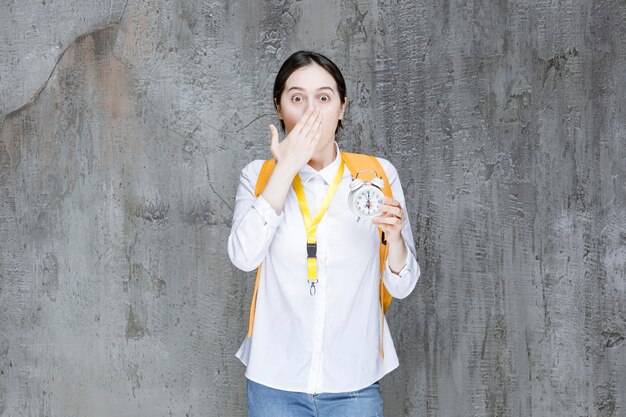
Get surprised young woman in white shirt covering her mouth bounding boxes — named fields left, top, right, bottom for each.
left=228, top=51, right=420, bottom=417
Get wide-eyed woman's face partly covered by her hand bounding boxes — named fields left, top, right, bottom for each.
left=277, top=63, right=347, bottom=149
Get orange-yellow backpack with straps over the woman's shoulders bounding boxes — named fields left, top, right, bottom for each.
left=248, top=152, right=393, bottom=357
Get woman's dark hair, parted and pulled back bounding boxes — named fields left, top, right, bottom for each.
left=274, top=51, right=346, bottom=133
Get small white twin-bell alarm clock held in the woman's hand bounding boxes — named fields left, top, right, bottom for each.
left=348, top=169, right=385, bottom=221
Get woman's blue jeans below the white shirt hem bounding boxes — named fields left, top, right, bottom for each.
left=246, top=379, right=383, bottom=417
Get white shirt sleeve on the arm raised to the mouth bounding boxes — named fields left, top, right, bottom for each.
left=228, top=160, right=285, bottom=271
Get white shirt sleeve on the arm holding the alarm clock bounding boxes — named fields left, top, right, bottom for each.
left=378, top=158, right=421, bottom=299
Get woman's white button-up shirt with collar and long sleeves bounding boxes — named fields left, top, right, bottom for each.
left=228, top=143, right=420, bottom=394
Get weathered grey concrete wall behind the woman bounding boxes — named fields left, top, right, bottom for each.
left=0, top=0, right=626, bottom=417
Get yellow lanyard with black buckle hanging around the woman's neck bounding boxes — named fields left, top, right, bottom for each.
left=293, top=158, right=344, bottom=295
